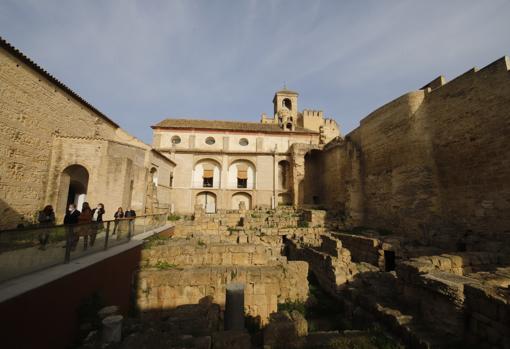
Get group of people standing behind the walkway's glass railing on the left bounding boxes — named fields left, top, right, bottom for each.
left=38, top=202, right=136, bottom=250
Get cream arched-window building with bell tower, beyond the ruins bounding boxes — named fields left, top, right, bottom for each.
left=152, top=90, right=339, bottom=214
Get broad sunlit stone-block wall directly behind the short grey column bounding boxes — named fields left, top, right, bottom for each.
left=136, top=262, right=308, bottom=323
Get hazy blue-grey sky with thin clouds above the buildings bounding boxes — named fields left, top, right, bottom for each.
left=0, top=0, right=510, bottom=143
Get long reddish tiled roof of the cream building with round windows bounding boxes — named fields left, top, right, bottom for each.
left=152, top=119, right=318, bottom=133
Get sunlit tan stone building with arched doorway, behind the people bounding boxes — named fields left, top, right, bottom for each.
left=0, top=39, right=172, bottom=228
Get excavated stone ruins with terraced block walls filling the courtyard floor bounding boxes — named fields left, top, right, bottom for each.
left=75, top=207, right=510, bottom=349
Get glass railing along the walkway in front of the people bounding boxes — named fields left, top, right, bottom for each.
left=0, top=213, right=167, bottom=282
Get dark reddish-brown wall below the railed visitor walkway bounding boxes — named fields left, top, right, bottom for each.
left=0, top=241, right=141, bottom=349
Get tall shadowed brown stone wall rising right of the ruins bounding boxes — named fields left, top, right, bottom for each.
left=310, top=57, right=510, bottom=239
